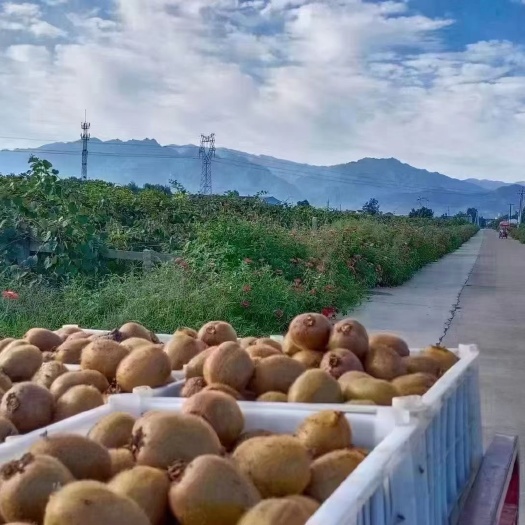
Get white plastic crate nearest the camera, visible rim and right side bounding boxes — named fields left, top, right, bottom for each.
left=0, top=389, right=422, bottom=525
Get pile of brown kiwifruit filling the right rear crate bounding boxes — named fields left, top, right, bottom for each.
left=176, top=313, right=458, bottom=406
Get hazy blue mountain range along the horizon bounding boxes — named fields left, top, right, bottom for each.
left=0, top=138, right=525, bottom=217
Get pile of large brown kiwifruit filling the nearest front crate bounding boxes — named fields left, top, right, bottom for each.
left=0, top=402, right=369, bottom=525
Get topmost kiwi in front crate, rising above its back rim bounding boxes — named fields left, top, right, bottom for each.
left=181, top=392, right=244, bottom=448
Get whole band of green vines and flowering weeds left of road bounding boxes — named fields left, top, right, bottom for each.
left=0, top=159, right=476, bottom=335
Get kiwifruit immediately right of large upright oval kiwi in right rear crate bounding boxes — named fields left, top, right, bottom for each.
left=249, top=355, right=306, bottom=396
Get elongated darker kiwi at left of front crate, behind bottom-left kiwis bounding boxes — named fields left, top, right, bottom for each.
left=29, top=434, right=111, bottom=481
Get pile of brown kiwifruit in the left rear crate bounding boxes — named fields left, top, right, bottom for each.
left=0, top=323, right=177, bottom=443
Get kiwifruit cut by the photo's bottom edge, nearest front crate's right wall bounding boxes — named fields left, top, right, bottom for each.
left=238, top=496, right=315, bottom=525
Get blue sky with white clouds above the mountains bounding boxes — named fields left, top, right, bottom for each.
left=0, top=0, right=525, bottom=181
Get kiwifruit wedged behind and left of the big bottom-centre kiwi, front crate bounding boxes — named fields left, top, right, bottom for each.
left=108, top=465, right=170, bottom=525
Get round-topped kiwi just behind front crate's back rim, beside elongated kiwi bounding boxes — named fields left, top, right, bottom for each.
left=288, top=368, right=343, bottom=403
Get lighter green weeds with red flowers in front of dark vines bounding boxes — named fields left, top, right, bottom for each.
left=0, top=217, right=476, bottom=337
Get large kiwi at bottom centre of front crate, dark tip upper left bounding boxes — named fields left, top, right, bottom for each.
left=169, top=455, right=261, bottom=525
